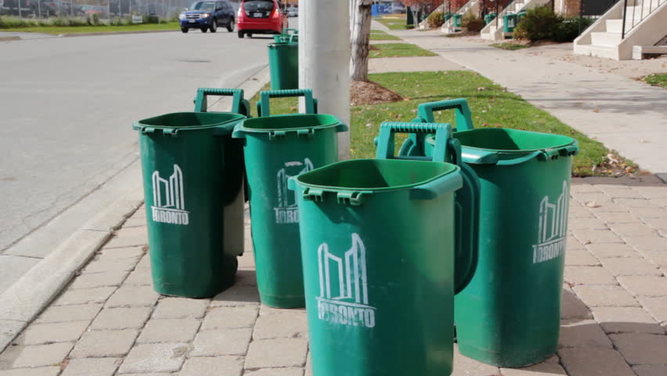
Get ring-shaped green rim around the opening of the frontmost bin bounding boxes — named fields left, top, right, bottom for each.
left=290, top=158, right=461, bottom=193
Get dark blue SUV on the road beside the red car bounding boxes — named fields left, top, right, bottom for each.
left=178, top=0, right=235, bottom=33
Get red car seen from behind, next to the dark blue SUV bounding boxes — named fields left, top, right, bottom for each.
left=236, top=0, right=288, bottom=38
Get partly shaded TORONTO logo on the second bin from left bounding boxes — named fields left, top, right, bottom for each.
left=273, top=158, right=313, bottom=224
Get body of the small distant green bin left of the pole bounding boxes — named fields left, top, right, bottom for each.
left=268, top=42, right=299, bottom=90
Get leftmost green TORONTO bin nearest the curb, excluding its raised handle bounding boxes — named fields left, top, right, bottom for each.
left=133, top=112, right=245, bottom=298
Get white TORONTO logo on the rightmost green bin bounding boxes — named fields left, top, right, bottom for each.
left=533, top=181, right=569, bottom=264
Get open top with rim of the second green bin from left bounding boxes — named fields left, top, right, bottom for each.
left=234, top=114, right=347, bottom=138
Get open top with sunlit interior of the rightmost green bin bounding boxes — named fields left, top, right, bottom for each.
left=426, top=128, right=579, bottom=164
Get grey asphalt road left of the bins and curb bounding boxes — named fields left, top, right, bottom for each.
left=0, top=29, right=270, bottom=253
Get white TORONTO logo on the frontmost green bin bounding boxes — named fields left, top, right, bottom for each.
left=316, top=234, right=375, bottom=328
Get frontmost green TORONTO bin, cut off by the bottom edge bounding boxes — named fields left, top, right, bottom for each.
left=290, top=123, right=462, bottom=376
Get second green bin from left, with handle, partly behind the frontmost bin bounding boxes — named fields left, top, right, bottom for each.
left=233, top=90, right=347, bottom=308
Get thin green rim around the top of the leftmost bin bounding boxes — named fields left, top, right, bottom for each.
left=132, top=111, right=247, bottom=133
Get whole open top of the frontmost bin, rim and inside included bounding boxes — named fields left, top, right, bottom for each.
left=290, top=159, right=462, bottom=205
